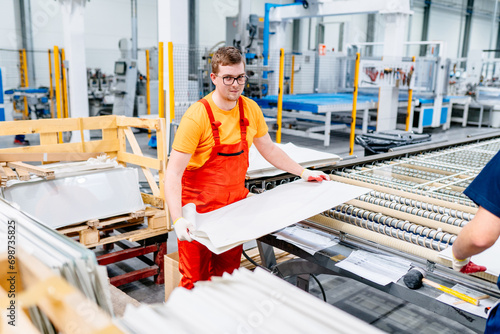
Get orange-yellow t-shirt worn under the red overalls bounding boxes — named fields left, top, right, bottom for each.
left=172, top=93, right=268, bottom=169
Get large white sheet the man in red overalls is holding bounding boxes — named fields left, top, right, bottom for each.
left=183, top=180, right=370, bottom=254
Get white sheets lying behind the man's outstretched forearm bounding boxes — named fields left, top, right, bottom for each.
left=247, top=143, right=340, bottom=178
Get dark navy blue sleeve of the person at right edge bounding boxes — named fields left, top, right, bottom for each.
left=464, top=152, right=500, bottom=218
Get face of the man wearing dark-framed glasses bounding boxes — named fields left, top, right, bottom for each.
left=210, top=63, right=245, bottom=101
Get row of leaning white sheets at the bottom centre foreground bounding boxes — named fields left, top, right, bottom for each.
left=120, top=268, right=382, bottom=334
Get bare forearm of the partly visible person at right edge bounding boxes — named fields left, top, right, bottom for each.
left=453, top=206, right=500, bottom=259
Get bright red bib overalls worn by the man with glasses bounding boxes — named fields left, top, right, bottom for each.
left=177, top=97, right=249, bottom=289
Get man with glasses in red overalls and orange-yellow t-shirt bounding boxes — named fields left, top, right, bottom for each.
left=165, top=47, right=329, bottom=289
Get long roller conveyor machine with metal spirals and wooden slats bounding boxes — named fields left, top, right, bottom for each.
left=247, top=133, right=500, bottom=332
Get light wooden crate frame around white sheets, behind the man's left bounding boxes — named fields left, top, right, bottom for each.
left=0, top=115, right=172, bottom=247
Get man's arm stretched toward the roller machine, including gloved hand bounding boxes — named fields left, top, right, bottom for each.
left=253, top=133, right=330, bottom=181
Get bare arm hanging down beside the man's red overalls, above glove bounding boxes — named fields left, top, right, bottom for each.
left=165, top=150, right=191, bottom=222
